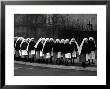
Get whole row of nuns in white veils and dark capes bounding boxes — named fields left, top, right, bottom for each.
left=14, top=37, right=96, bottom=67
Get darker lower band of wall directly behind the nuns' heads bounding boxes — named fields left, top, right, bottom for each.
left=14, top=26, right=97, bottom=45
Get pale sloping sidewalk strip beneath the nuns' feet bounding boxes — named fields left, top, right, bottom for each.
left=14, top=61, right=97, bottom=71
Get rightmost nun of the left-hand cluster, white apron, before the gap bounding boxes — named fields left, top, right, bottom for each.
left=27, top=38, right=36, bottom=62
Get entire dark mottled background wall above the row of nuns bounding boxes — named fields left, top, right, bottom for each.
left=14, top=14, right=97, bottom=45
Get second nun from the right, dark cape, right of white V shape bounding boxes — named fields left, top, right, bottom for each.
left=80, top=38, right=89, bottom=67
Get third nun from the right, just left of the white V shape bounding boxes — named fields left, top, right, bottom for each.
left=70, top=38, right=78, bottom=64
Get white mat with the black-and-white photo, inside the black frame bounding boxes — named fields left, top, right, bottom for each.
left=4, top=3, right=106, bottom=85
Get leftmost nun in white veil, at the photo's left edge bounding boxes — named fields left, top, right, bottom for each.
left=15, top=37, right=24, bottom=60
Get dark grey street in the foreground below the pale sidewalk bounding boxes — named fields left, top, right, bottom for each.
left=14, top=63, right=97, bottom=76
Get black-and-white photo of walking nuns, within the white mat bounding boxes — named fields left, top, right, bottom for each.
left=14, top=14, right=97, bottom=76
